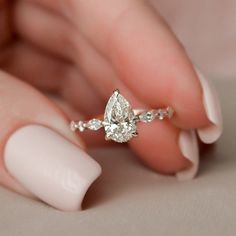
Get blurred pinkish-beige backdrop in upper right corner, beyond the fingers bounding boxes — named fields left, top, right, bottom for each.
left=152, top=0, right=236, bottom=79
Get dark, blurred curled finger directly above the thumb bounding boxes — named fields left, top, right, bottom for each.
left=0, top=42, right=103, bottom=116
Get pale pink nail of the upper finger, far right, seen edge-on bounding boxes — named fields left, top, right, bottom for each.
left=196, top=69, right=223, bottom=143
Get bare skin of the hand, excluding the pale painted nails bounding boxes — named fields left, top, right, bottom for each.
left=0, top=0, right=210, bottom=193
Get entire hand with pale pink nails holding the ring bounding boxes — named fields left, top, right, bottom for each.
left=0, top=0, right=222, bottom=210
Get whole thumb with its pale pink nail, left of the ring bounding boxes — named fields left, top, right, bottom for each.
left=0, top=72, right=100, bottom=210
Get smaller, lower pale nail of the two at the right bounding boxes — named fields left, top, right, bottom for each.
left=176, top=130, right=199, bottom=180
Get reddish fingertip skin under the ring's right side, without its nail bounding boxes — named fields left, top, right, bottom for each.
left=130, top=121, right=191, bottom=175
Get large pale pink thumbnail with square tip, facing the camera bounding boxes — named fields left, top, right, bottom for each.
left=4, top=125, right=101, bottom=211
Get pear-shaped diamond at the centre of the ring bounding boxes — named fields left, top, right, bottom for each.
left=104, top=90, right=137, bottom=143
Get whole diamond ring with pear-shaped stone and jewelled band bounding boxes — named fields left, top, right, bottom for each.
left=70, top=89, right=174, bottom=143
